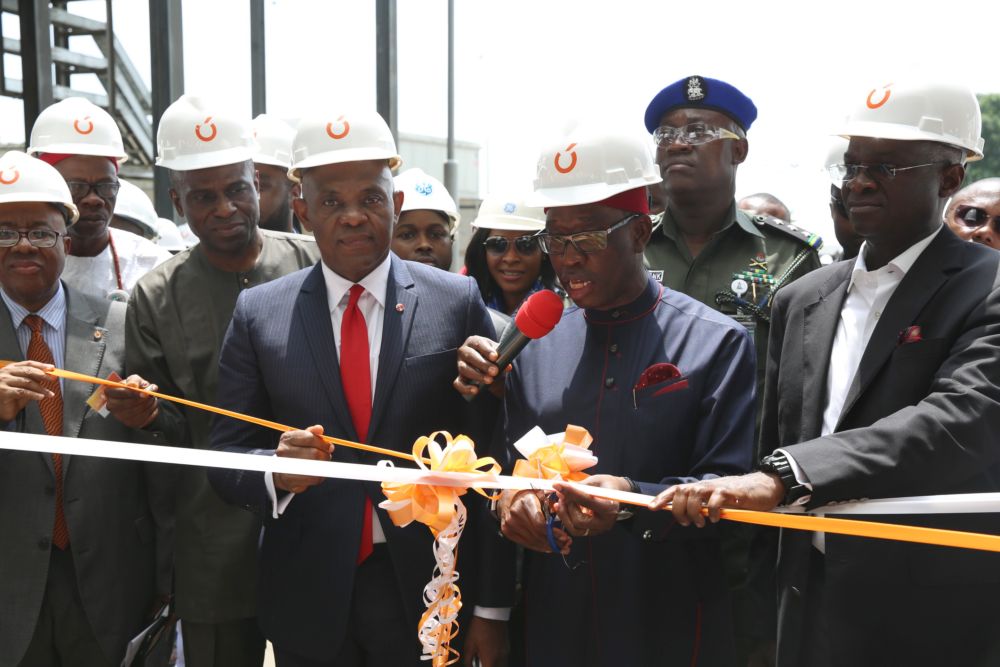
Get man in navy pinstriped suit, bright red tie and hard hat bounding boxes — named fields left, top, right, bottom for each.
left=212, top=113, right=511, bottom=667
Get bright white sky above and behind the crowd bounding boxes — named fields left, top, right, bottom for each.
left=0, top=0, right=1000, bottom=253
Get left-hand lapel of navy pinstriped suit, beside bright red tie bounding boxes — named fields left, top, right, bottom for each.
left=295, top=263, right=358, bottom=458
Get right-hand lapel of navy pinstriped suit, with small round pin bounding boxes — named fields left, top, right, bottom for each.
left=368, top=255, right=417, bottom=444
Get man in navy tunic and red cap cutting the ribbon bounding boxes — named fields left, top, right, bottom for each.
left=455, top=131, right=754, bottom=667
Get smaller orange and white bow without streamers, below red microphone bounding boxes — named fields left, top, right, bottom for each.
left=514, top=424, right=597, bottom=482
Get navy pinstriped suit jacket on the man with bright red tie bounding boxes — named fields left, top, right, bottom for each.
left=210, top=255, right=504, bottom=662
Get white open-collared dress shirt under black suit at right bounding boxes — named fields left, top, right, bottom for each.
left=778, top=227, right=941, bottom=551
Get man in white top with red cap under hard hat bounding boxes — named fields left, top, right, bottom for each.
left=28, top=97, right=170, bottom=301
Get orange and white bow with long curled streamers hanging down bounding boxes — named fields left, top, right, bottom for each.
left=379, top=431, right=500, bottom=667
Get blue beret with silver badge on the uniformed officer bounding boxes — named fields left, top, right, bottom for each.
left=646, top=76, right=757, bottom=134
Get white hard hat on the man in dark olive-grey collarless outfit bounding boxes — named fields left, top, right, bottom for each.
left=156, top=95, right=257, bottom=171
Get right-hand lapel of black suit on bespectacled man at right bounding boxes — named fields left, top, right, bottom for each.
left=840, top=227, right=964, bottom=422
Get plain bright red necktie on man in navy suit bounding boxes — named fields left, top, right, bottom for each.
left=340, top=285, right=373, bottom=565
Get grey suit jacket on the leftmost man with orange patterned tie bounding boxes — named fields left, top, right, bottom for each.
left=0, top=287, right=174, bottom=667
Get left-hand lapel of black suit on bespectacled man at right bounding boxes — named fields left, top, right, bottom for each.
left=800, top=262, right=854, bottom=438
